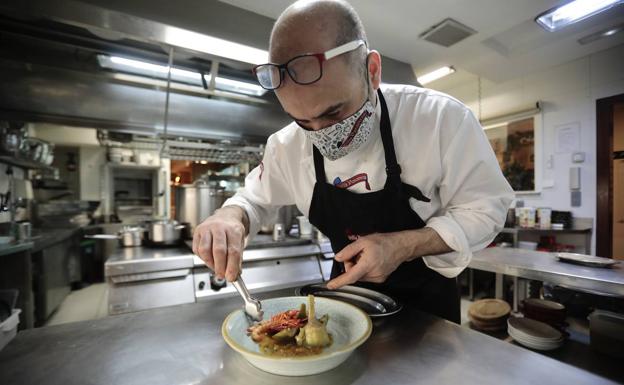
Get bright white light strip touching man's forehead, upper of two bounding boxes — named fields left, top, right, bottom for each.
left=165, top=27, right=269, bottom=64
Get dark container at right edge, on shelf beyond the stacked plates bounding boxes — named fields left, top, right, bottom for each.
left=589, top=310, right=624, bottom=359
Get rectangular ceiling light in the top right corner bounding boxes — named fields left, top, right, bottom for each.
left=535, top=0, right=623, bottom=32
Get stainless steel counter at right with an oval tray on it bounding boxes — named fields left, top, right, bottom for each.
left=468, top=247, right=624, bottom=297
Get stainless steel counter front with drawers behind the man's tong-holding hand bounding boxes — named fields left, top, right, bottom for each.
left=105, top=244, right=323, bottom=314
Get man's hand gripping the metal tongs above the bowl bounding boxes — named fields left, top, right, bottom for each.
left=193, top=206, right=249, bottom=282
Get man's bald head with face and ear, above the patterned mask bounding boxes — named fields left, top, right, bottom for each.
left=269, top=0, right=381, bottom=130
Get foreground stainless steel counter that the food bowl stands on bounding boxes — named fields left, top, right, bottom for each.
left=0, top=291, right=614, bottom=385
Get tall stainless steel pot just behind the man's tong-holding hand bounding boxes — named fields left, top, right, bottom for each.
left=175, top=180, right=225, bottom=235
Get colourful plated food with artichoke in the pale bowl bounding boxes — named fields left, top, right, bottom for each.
left=247, top=295, right=332, bottom=357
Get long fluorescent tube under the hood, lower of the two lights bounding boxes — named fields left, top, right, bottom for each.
left=97, top=54, right=266, bottom=96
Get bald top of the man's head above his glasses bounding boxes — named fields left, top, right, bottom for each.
left=269, top=0, right=368, bottom=63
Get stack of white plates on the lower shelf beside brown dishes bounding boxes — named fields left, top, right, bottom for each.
left=507, top=317, right=565, bottom=350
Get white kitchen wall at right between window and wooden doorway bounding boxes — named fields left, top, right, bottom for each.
left=431, top=45, right=624, bottom=250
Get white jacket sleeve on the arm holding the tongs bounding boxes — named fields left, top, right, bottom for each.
left=223, top=134, right=294, bottom=237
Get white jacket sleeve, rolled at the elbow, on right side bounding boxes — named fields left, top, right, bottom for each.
left=424, top=109, right=514, bottom=278
